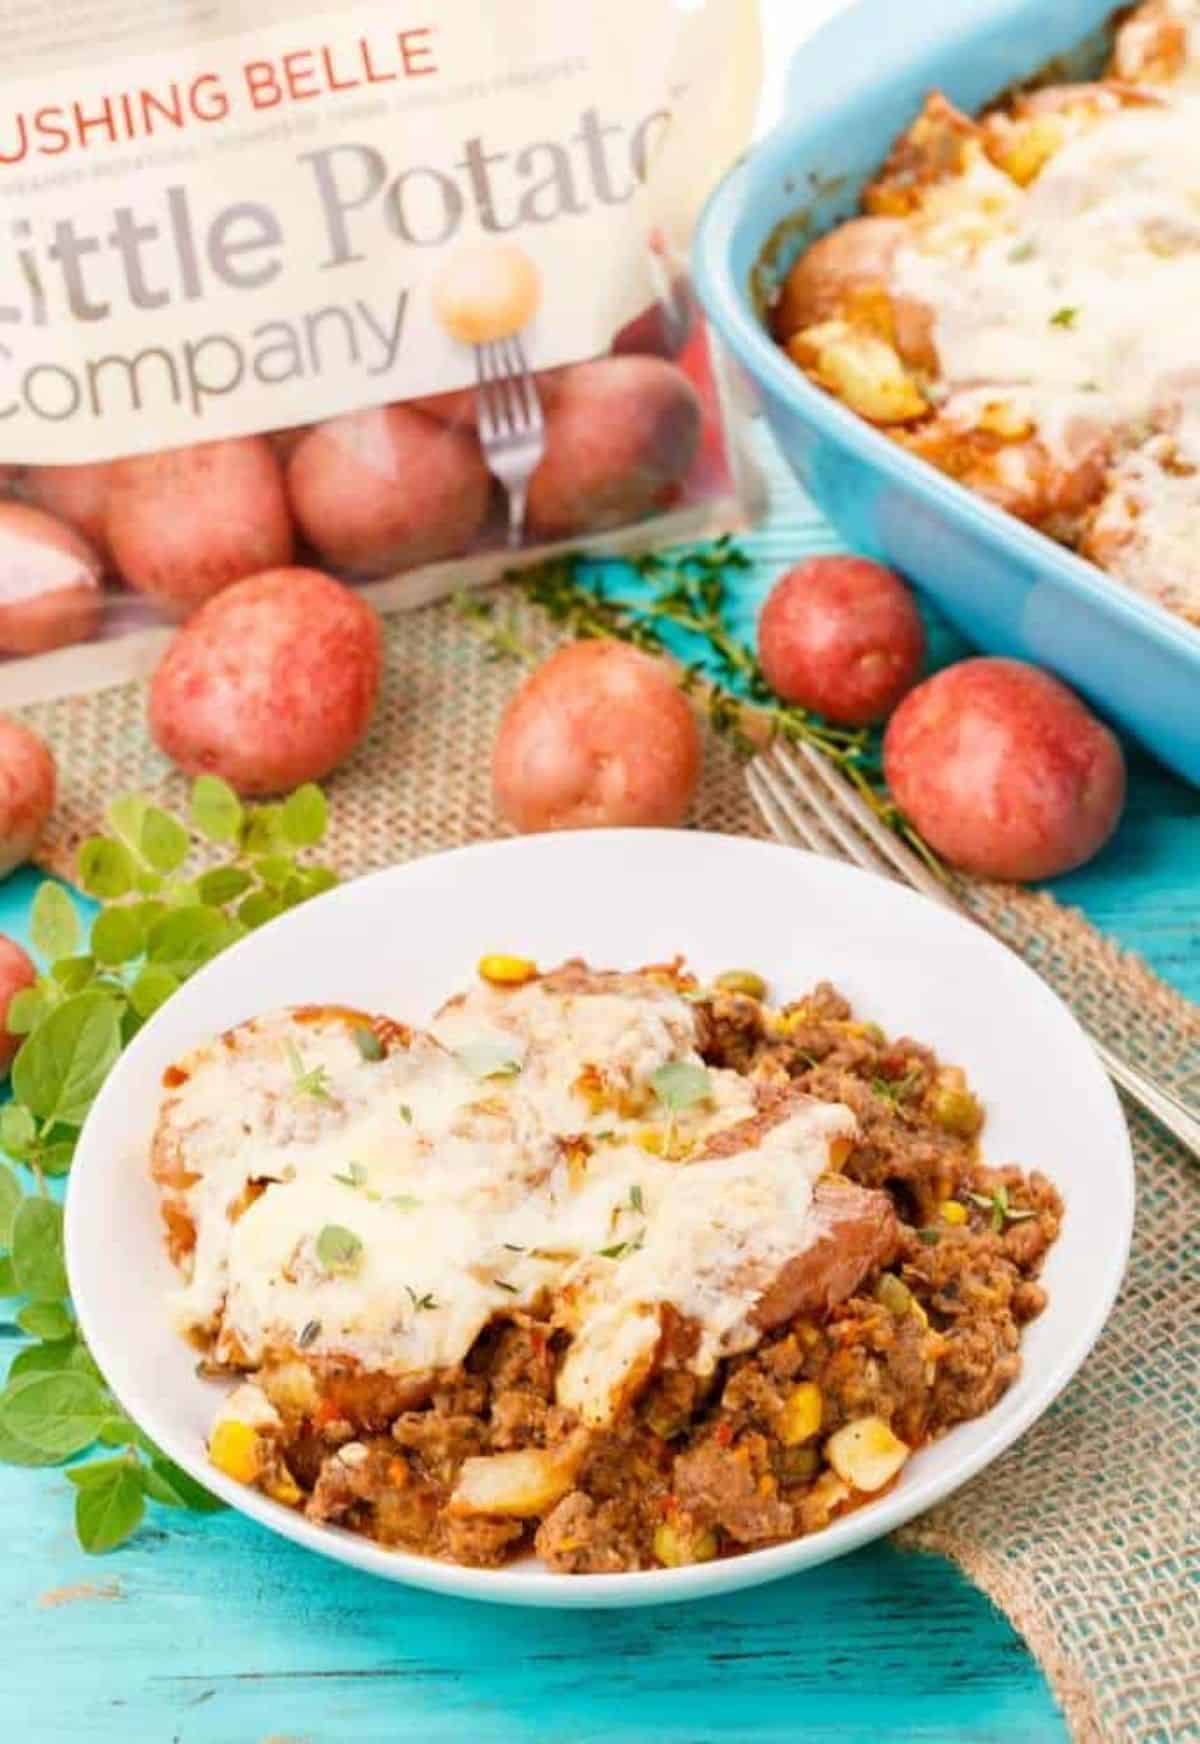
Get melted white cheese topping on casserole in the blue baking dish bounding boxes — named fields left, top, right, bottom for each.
left=893, top=57, right=1200, bottom=617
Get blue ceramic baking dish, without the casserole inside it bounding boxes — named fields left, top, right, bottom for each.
left=694, top=0, right=1200, bottom=785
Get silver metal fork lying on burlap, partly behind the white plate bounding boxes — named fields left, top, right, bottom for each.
left=747, top=743, right=1200, bottom=1156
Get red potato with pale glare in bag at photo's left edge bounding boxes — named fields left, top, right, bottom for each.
left=0, top=502, right=103, bottom=654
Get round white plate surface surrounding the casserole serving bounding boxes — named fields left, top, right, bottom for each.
left=66, top=830, right=1134, bottom=1604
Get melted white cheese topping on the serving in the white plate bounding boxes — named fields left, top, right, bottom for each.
left=156, top=984, right=855, bottom=1423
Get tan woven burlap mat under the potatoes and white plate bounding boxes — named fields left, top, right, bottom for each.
left=11, top=589, right=1200, bottom=1744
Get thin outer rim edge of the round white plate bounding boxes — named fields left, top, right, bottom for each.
left=65, top=828, right=1135, bottom=1610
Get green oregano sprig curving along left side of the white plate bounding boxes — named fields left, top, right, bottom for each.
left=0, top=776, right=337, bottom=1552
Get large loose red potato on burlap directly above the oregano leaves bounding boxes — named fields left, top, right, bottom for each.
left=150, top=569, right=384, bottom=797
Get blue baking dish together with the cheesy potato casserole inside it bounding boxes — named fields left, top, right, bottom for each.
left=696, top=0, right=1200, bottom=781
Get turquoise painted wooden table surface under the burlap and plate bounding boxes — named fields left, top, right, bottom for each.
left=0, top=439, right=1200, bottom=1744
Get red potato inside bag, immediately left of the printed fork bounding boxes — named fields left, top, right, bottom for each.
left=288, top=406, right=492, bottom=576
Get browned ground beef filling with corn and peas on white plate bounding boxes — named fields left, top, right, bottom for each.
left=244, top=985, right=1062, bottom=1573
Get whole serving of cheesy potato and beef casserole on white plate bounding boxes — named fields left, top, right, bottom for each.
left=152, top=957, right=1062, bottom=1573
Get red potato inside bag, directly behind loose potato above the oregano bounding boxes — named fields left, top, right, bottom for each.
left=108, top=436, right=293, bottom=617
